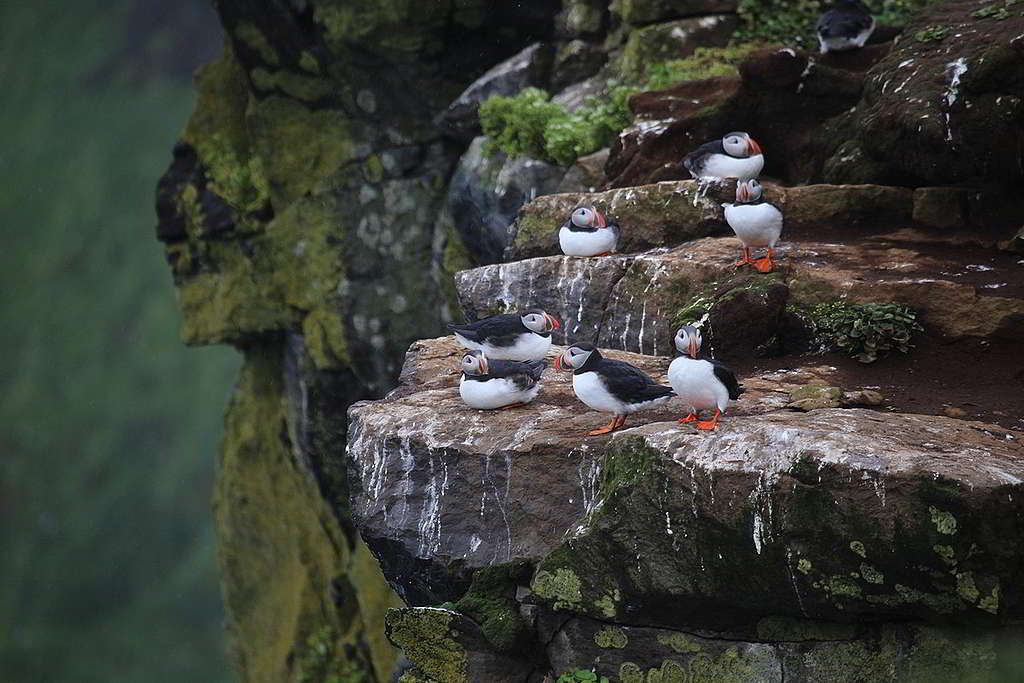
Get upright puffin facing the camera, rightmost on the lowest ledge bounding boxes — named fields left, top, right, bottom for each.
left=669, top=325, right=743, bottom=429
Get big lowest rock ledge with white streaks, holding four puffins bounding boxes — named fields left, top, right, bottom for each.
left=347, top=339, right=1024, bottom=682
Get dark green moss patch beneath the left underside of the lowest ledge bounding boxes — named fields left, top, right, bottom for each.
left=455, top=562, right=529, bottom=652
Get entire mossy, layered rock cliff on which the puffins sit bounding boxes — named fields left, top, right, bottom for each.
left=158, top=0, right=1024, bottom=683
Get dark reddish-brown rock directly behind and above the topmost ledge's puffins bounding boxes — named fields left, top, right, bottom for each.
left=608, top=47, right=876, bottom=187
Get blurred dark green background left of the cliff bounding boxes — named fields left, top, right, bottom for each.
left=0, top=0, right=239, bottom=683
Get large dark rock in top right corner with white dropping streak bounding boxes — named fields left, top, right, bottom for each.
left=821, top=1, right=1024, bottom=186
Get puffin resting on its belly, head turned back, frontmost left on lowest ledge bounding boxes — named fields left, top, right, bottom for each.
left=459, top=350, right=548, bottom=411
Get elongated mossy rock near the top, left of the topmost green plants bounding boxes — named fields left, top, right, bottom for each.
left=618, top=14, right=739, bottom=80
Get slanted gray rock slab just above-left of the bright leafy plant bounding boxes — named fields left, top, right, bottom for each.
left=438, top=43, right=553, bottom=140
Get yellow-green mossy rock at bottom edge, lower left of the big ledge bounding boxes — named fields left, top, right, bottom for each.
left=387, top=607, right=469, bottom=683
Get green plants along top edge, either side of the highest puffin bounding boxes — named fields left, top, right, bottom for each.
left=734, top=0, right=937, bottom=47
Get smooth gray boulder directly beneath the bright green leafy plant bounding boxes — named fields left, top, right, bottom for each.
left=441, top=137, right=565, bottom=263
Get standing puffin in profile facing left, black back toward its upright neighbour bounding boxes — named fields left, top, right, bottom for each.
left=555, top=343, right=676, bottom=436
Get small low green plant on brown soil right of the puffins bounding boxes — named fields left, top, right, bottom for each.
left=811, top=302, right=923, bottom=362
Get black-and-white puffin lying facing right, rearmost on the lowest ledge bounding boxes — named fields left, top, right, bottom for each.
left=449, top=308, right=562, bottom=360
